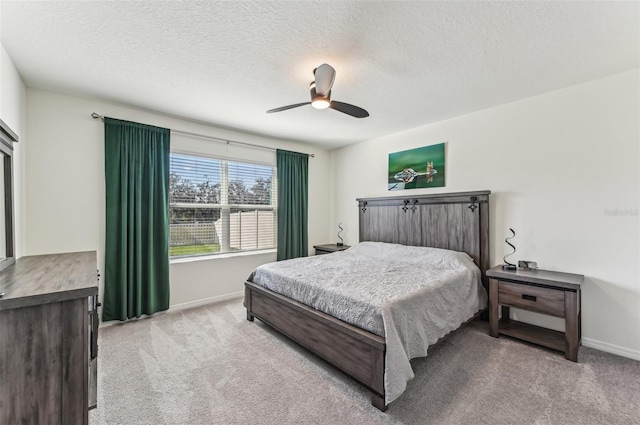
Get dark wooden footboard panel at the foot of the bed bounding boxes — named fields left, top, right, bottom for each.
left=244, top=282, right=386, bottom=411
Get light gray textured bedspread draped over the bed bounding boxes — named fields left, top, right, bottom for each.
left=249, top=242, right=487, bottom=404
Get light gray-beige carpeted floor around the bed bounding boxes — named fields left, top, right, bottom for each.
left=90, top=300, right=640, bottom=425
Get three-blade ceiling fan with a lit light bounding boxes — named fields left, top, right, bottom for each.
left=267, top=63, right=369, bottom=118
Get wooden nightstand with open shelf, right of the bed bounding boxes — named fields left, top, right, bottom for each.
left=487, top=266, right=584, bottom=362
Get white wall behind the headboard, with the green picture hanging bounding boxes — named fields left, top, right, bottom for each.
left=332, top=70, right=640, bottom=359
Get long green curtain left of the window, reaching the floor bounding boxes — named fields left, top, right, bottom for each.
left=102, top=118, right=170, bottom=321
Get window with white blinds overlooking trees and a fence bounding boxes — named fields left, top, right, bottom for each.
left=169, top=153, right=277, bottom=257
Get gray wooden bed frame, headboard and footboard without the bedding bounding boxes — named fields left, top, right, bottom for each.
left=244, top=190, right=491, bottom=411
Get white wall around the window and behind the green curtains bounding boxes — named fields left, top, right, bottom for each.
left=25, top=88, right=330, bottom=306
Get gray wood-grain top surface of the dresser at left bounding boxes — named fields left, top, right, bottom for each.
left=0, top=251, right=98, bottom=310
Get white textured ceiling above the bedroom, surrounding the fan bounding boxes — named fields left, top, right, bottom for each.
left=0, top=1, right=640, bottom=148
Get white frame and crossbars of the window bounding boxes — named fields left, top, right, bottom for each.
left=168, top=149, right=278, bottom=262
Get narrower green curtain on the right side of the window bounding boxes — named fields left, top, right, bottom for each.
left=276, top=149, right=309, bottom=261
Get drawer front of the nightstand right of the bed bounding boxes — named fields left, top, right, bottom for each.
left=498, top=282, right=564, bottom=317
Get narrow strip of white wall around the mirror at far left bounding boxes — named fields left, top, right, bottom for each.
left=0, top=43, right=27, bottom=257
